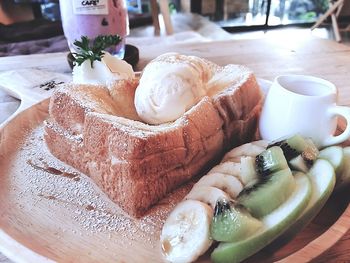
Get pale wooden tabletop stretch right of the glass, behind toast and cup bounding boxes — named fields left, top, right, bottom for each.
left=133, top=36, right=350, bottom=105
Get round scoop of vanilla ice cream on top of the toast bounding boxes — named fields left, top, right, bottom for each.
left=135, top=53, right=209, bottom=124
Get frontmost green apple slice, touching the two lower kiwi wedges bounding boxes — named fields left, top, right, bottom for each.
left=211, top=174, right=312, bottom=263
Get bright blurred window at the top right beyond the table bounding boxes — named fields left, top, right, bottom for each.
left=181, top=0, right=328, bottom=28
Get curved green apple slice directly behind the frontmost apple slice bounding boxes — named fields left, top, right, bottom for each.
left=274, top=159, right=336, bottom=245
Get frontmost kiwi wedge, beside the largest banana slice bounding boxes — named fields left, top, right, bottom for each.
left=210, top=199, right=263, bottom=242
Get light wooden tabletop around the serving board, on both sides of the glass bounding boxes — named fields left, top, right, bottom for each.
left=0, top=36, right=350, bottom=262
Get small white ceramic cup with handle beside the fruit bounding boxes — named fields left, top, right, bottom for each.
left=259, top=75, right=350, bottom=147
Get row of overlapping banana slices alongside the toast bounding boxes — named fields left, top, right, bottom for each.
left=160, top=140, right=268, bottom=263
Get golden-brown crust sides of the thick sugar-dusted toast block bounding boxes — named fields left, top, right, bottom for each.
left=45, top=63, right=262, bottom=217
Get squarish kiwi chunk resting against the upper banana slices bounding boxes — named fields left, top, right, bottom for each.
left=255, top=146, right=288, bottom=177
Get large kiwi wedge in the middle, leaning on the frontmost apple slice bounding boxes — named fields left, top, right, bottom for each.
left=237, top=168, right=295, bottom=218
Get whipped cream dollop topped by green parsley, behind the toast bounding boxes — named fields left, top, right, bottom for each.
left=73, top=52, right=135, bottom=86
